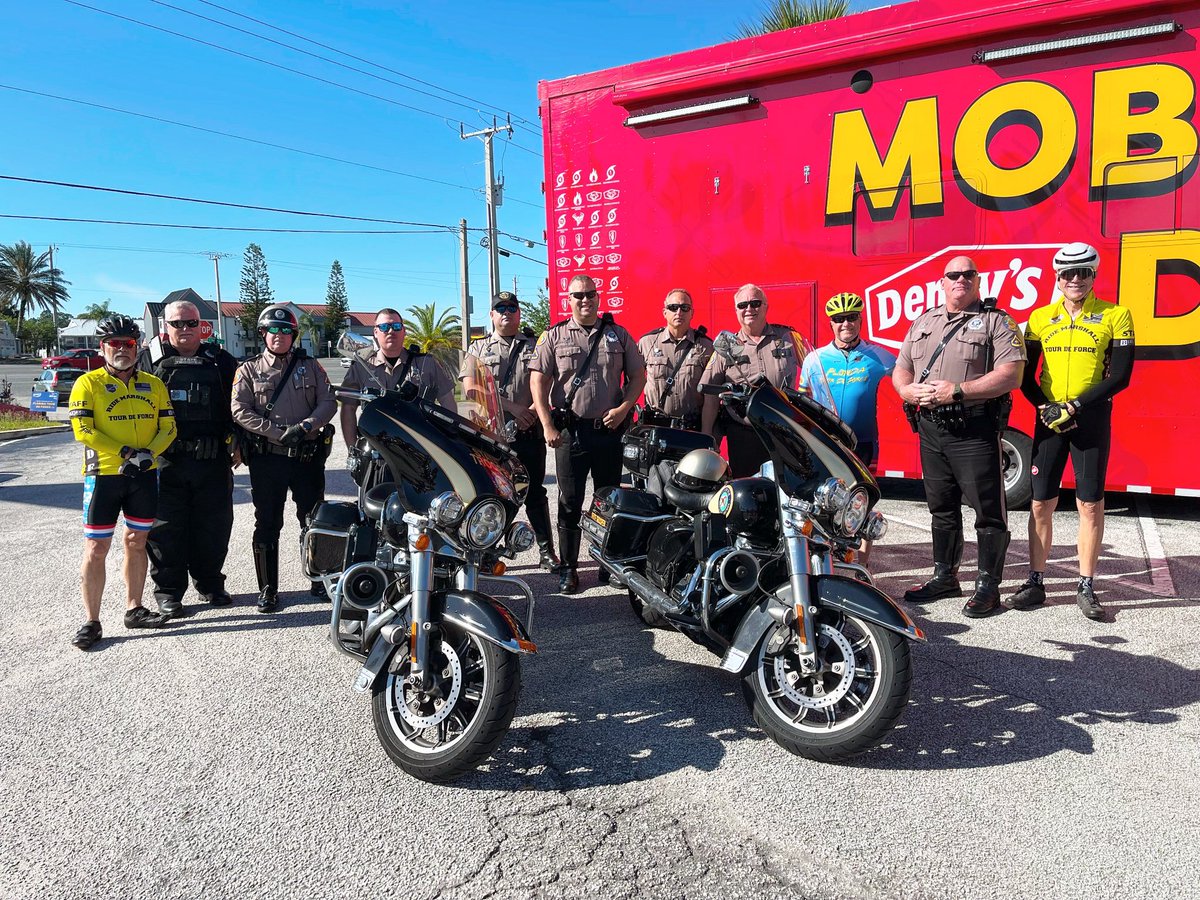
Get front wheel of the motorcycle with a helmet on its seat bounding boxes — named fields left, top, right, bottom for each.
left=744, top=611, right=912, bottom=762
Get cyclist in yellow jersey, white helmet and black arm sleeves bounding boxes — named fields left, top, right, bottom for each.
left=1004, top=242, right=1134, bottom=620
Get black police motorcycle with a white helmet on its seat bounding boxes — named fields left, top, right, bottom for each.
left=583, top=336, right=925, bottom=762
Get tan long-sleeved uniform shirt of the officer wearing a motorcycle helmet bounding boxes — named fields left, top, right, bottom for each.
left=229, top=350, right=337, bottom=444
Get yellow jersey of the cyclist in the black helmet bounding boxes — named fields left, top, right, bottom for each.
left=70, top=368, right=175, bottom=475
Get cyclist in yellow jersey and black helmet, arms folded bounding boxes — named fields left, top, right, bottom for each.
left=70, top=316, right=175, bottom=650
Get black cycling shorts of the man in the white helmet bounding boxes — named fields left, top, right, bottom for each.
left=1030, top=403, right=1112, bottom=503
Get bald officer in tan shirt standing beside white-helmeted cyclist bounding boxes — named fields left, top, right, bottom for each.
left=892, top=257, right=1025, bottom=618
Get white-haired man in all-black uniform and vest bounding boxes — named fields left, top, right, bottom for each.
left=138, top=300, right=238, bottom=616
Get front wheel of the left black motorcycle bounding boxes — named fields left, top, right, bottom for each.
left=371, top=625, right=521, bottom=782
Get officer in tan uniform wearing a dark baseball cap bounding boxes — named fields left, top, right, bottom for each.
left=467, top=290, right=559, bottom=570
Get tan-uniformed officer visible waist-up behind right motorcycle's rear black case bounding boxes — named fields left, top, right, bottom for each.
left=637, top=288, right=713, bottom=431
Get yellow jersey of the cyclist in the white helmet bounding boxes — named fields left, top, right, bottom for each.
left=1025, top=293, right=1133, bottom=403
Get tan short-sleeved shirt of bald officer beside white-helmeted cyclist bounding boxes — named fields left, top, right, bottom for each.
left=896, top=300, right=1025, bottom=406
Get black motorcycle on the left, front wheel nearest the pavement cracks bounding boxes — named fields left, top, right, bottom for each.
left=301, top=334, right=536, bottom=782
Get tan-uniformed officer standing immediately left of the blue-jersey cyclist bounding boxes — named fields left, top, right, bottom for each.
left=700, top=284, right=802, bottom=478
